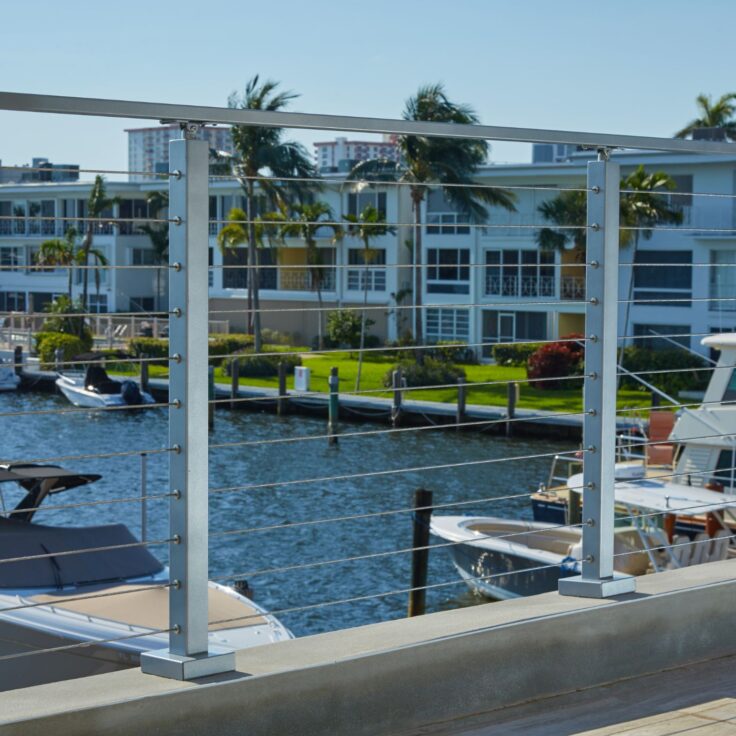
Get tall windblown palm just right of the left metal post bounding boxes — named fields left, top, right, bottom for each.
left=220, top=74, right=318, bottom=352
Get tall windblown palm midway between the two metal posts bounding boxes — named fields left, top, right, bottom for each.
left=350, top=84, right=516, bottom=348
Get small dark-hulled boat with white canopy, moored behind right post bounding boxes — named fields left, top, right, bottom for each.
left=430, top=484, right=736, bottom=600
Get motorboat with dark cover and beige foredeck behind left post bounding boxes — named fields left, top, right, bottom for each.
left=0, top=465, right=293, bottom=690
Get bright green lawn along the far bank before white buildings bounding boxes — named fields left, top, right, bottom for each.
left=112, top=347, right=650, bottom=414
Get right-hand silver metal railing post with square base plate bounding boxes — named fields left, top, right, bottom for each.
left=559, top=151, right=635, bottom=598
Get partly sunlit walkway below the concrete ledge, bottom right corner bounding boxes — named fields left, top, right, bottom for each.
left=412, top=643, right=736, bottom=736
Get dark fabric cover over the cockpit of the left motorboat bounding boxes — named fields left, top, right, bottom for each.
left=0, top=517, right=163, bottom=589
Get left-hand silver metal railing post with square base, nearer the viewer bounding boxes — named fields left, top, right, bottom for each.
left=141, top=125, right=235, bottom=680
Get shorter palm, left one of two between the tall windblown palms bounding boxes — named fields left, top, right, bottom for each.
left=272, top=202, right=344, bottom=350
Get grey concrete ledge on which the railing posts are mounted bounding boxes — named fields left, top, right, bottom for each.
left=0, top=561, right=736, bottom=736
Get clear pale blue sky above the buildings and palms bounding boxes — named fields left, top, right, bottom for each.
left=0, top=0, right=736, bottom=175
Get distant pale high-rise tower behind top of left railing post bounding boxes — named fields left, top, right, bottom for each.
left=125, top=124, right=233, bottom=181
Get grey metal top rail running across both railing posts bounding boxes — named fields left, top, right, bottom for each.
left=0, top=92, right=736, bottom=155
